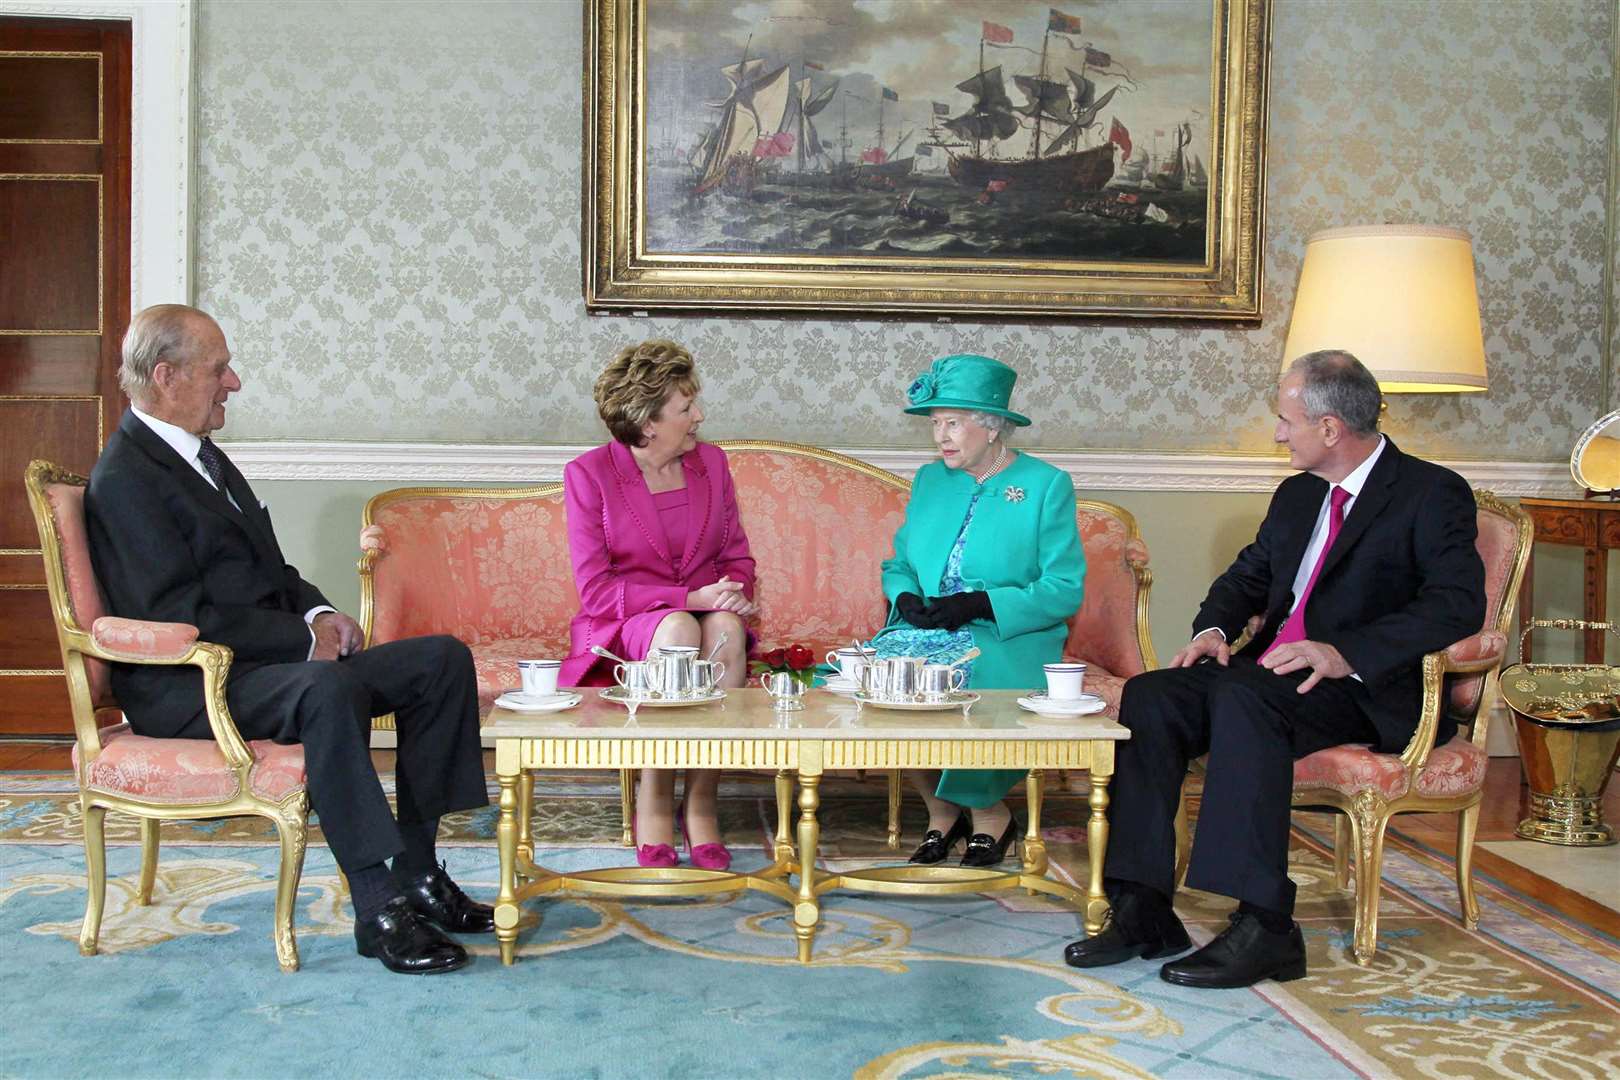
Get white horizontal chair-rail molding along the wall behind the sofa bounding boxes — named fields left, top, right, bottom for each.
left=220, top=439, right=1580, bottom=497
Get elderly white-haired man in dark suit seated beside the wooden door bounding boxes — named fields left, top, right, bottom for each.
left=84, top=304, right=494, bottom=973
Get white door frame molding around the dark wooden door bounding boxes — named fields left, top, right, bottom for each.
left=0, top=0, right=194, bottom=307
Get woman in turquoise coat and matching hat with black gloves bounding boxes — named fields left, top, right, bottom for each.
left=873, top=355, right=1085, bottom=866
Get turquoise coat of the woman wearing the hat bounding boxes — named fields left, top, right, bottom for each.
left=883, top=453, right=1085, bottom=808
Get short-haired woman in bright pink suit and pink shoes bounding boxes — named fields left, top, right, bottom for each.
left=559, top=342, right=755, bottom=870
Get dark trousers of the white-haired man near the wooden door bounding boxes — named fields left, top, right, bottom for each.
left=180, top=636, right=489, bottom=871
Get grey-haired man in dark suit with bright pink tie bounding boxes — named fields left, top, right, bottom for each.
left=1064, top=351, right=1486, bottom=988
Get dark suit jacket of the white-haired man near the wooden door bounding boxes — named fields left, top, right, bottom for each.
left=84, top=413, right=327, bottom=737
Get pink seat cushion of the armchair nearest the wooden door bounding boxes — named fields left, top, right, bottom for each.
left=73, top=724, right=305, bottom=803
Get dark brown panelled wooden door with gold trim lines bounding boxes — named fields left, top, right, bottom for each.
left=0, top=18, right=130, bottom=735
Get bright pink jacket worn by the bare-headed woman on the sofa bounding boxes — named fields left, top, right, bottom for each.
left=557, top=440, right=753, bottom=687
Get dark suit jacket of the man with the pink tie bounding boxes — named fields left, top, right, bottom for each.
left=1192, top=442, right=1486, bottom=751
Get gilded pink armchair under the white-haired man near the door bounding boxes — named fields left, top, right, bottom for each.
left=24, top=461, right=308, bottom=972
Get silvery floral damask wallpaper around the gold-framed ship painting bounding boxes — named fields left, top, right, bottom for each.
left=194, top=0, right=1615, bottom=461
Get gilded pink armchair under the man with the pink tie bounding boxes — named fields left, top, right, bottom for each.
left=1176, top=491, right=1534, bottom=963
